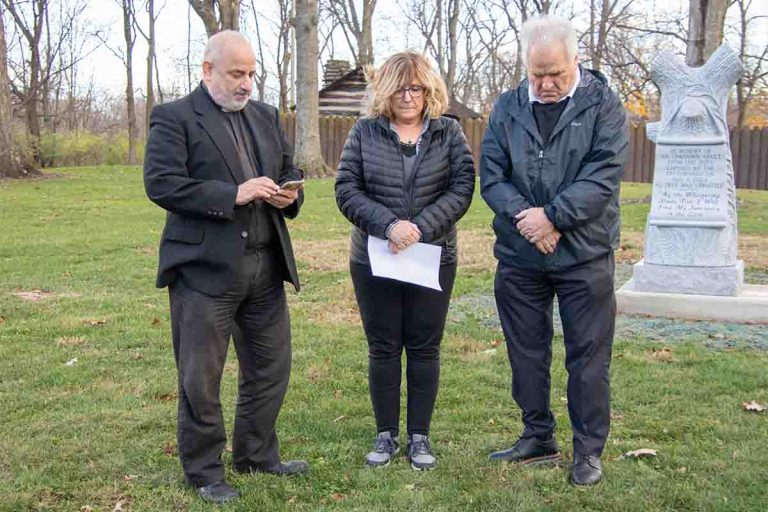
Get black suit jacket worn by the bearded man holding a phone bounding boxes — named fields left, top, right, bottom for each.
left=144, top=86, right=304, bottom=295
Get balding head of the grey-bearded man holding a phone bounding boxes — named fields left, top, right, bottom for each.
left=203, top=30, right=256, bottom=110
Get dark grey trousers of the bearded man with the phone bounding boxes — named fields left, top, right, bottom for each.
left=170, top=250, right=291, bottom=486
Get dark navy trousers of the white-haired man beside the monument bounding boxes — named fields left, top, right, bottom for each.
left=495, top=253, right=616, bottom=455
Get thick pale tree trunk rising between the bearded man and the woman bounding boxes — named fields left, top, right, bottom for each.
left=294, top=0, right=330, bottom=177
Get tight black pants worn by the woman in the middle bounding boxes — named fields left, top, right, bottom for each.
left=350, top=263, right=456, bottom=435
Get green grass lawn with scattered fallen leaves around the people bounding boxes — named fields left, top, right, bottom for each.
left=0, top=167, right=768, bottom=512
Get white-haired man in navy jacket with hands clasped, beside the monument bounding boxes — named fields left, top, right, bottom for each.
left=480, top=16, right=629, bottom=485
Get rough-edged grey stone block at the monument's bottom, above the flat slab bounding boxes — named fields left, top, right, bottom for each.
left=632, top=260, right=744, bottom=297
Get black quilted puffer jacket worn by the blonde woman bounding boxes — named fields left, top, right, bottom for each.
left=336, top=116, right=475, bottom=264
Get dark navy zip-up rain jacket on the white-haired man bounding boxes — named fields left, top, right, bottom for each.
left=480, top=69, right=629, bottom=270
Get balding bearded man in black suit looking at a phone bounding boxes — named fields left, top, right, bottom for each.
left=144, top=31, right=309, bottom=502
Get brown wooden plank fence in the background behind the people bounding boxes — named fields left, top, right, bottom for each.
left=282, top=114, right=768, bottom=190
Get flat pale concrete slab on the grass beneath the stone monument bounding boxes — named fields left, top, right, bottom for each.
left=616, top=279, right=768, bottom=324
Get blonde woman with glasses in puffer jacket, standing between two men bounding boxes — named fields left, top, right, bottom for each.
left=336, top=52, right=475, bottom=469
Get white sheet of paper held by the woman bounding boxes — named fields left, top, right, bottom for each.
left=368, top=236, right=443, bottom=291
